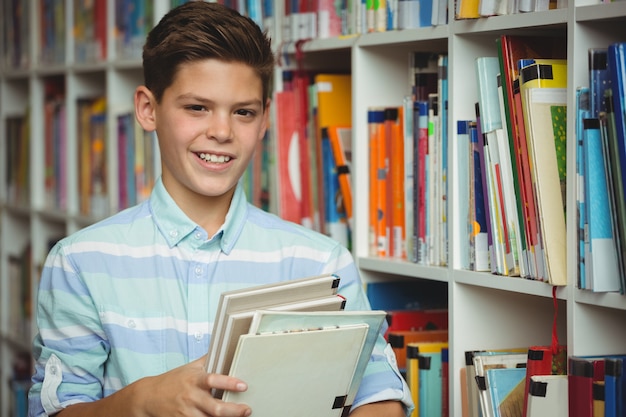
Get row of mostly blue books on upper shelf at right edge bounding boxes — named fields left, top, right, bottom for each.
left=576, top=43, right=626, bottom=293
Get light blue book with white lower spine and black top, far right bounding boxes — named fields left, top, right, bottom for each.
left=583, top=118, right=621, bottom=292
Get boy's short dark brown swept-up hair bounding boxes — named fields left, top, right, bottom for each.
left=143, top=1, right=274, bottom=106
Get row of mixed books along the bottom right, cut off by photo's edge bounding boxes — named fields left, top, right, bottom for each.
left=460, top=345, right=626, bottom=417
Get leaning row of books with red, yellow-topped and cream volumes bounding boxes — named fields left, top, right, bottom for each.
left=457, top=35, right=567, bottom=285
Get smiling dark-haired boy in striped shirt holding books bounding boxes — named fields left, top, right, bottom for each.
left=29, top=1, right=411, bottom=417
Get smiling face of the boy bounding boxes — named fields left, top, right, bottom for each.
left=154, top=59, right=269, bottom=207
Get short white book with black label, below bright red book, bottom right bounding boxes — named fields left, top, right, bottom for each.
left=526, top=375, right=569, bottom=417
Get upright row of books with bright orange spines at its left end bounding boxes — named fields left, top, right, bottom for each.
left=368, top=53, right=448, bottom=266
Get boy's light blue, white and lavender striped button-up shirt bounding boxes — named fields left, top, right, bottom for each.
left=29, top=177, right=412, bottom=417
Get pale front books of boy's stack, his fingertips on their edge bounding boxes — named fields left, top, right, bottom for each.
left=223, top=310, right=385, bottom=417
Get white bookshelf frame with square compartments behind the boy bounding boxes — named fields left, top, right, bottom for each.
left=0, top=0, right=626, bottom=417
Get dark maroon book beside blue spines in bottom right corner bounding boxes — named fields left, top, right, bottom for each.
left=567, top=356, right=604, bottom=417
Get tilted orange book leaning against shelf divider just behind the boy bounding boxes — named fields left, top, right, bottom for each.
left=328, top=126, right=353, bottom=228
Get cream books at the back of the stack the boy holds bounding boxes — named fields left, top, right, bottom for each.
left=206, top=274, right=339, bottom=373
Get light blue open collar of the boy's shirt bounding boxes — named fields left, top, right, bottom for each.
left=150, top=177, right=248, bottom=254
